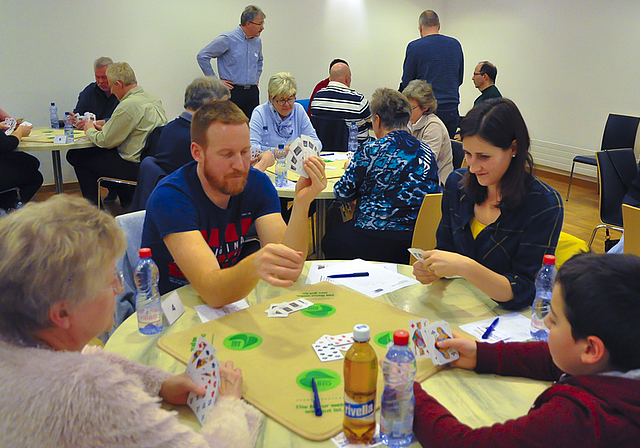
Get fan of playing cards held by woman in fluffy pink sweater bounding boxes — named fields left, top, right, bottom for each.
left=186, top=337, right=220, bottom=424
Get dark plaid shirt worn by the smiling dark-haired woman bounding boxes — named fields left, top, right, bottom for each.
left=436, top=168, right=564, bottom=309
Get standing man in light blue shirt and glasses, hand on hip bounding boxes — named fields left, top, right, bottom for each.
left=197, top=5, right=266, bottom=118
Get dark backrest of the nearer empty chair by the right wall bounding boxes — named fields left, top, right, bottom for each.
left=596, top=149, right=637, bottom=226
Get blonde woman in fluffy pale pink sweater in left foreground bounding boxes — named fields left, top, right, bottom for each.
left=0, top=194, right=261, bottom=447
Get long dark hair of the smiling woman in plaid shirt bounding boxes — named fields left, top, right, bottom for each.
left=460, top=98, right=533, bottom=210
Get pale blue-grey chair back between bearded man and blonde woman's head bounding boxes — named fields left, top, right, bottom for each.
left=110, top=210, right=146, bottom=341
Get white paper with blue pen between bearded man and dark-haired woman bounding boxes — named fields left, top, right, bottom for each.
left=306, top=259, right=418, bottom=297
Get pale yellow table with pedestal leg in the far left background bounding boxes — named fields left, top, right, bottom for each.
left=18, top=127, right=94, bottom=193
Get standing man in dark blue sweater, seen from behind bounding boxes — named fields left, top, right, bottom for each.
left=400, top=9, right=464, bottom=138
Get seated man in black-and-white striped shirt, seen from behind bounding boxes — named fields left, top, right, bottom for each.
left=309, top=62, right=371, bottom=149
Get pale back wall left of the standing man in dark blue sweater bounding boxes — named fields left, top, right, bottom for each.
left=0, top=0, right=436, bottom=183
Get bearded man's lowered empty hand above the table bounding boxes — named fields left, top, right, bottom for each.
left=254, top=244, right=304, bottom=287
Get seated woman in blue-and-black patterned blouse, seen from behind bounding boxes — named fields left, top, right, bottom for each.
left=322, top=89, right=440, bottom=263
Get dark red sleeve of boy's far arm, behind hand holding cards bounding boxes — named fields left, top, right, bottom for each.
left=475, top=342, right=564, bottom=381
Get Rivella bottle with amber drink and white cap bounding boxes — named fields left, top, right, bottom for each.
left=343, top=324, right=378, bottom=444
